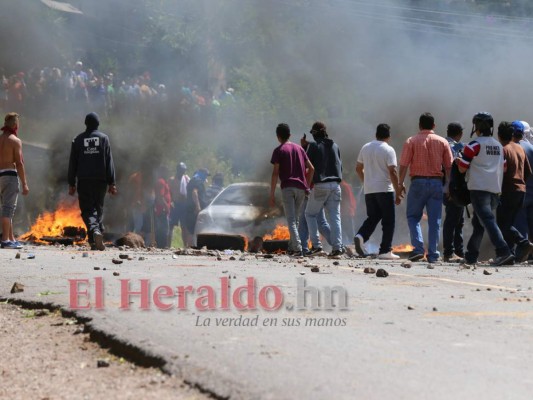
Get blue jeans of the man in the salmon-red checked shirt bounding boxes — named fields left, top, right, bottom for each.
left=406, top=178, right=443, bottom=261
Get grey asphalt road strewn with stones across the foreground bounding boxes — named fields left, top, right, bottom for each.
left=0, top=247, right=533, bottom=400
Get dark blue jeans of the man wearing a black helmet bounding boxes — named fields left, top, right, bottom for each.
left=465, top=190, right=511, bottom=264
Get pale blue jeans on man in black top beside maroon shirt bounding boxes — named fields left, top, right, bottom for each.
left=305, top=182, right=342, bottom=251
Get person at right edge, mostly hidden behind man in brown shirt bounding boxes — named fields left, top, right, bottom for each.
left=513, top=121, right=533, bottom=241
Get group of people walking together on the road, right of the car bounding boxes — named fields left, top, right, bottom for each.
left=270, top=112, right=533, bottom=266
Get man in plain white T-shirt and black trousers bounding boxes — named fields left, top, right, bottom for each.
left=354, top=124, right=402, bottom=260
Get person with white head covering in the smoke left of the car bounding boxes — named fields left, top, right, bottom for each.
left=168, top=162, right=193, bottom=247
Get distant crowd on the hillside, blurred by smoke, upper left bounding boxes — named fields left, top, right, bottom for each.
left=0, top=61, right=234, bottom=117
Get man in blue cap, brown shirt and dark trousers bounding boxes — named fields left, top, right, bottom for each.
left=496, top=121, right=533, bottom=263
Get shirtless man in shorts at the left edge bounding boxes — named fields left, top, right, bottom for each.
left=0, top=112, right=30, bottom=249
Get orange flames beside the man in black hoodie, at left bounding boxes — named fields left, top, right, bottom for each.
left=21, top=200, right=85, bottom=243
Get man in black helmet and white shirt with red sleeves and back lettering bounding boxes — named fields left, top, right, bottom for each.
left=458, top=112, right=514, bottom=266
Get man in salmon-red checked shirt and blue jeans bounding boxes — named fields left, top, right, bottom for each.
left=399, top=113, right=452, bottom=263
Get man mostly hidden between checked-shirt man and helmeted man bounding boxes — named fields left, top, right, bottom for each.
left=442, top=122, right=465, bottom=262
